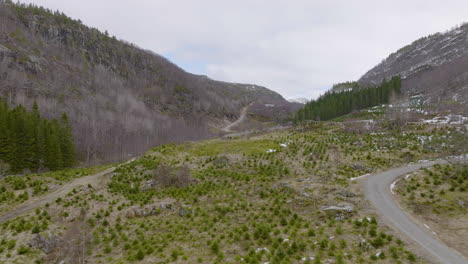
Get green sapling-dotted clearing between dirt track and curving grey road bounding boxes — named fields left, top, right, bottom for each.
left=0, top=112, right=467, bottom=263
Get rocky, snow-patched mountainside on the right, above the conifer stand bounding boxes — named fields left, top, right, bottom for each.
left=358, top=24, right=468, bottom=113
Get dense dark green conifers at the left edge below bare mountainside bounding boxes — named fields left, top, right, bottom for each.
left=0, top=98, right=76, bottom=173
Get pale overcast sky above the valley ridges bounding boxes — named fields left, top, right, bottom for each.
left=22, top=0, right=468, bottom=99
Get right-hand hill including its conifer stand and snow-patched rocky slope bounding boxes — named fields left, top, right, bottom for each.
left=295, top=24, right=468, bottom=123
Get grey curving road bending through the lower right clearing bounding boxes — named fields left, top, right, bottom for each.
left=364, top=159, right=468, bottom=264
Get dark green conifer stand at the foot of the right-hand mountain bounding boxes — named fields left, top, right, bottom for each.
left=294, top=76, right=401, bottom=123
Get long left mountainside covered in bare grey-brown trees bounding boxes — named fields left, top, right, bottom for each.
left=0, top=0, right=294, bottom=163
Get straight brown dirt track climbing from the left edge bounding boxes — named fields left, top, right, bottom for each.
left=0, top=167, right=116, bottom=224
